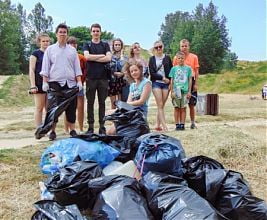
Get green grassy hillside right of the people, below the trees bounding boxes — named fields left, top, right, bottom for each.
left=199, top=61, right=267, bottom=94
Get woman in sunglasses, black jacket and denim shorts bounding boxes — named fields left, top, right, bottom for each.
left=148, top=41, right=172, bottom=131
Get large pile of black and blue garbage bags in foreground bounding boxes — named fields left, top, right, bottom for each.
left=32, top=104, right=267, bottom=220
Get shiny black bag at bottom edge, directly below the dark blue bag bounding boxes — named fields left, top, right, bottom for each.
left=142, top=172, right=225, bottom=220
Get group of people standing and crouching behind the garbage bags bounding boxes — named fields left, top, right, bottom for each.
left=29, top=24, right=199, bottom=140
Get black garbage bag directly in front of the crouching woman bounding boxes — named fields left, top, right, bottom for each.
left=104, top=101, right=150, bottom=138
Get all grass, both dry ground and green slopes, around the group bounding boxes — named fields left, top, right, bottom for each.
left=0, top=62, right=267, bottom=220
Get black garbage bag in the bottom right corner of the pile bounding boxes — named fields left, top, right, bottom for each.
left=215, top=171, right=267, bottom=220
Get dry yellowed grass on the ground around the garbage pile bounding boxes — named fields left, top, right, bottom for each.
left=0, top=95, right=267, bottom=219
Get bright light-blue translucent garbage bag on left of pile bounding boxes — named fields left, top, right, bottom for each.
left=40, top=138, right=120, bottom=175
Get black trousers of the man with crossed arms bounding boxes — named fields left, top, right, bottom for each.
left=86, top=78, right=108, bottom=128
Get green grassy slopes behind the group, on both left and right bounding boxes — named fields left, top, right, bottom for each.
left=0, top=60, right=267, bottom=106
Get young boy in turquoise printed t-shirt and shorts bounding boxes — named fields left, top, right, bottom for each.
left=169, top=52, right=192, bottom=130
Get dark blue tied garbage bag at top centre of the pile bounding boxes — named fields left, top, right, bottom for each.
left=135, top=133, right=185, bottom=175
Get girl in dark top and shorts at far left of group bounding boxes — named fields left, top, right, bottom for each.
left=29, top=33, right=50, bottom=127
